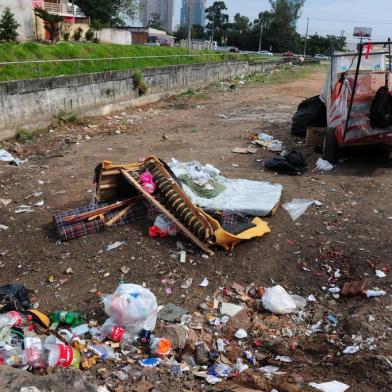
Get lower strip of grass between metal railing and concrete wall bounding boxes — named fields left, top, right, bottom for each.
left=0, top=52, right=256, bottom=81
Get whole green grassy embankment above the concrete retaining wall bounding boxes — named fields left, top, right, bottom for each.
left=0, top=42, right=270, bottom=81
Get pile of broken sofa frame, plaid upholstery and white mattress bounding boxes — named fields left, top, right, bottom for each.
left=53, top=157, right=282, bottom=256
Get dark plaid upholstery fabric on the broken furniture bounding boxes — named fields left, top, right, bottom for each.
left=53, top=201, right=158, bottom=241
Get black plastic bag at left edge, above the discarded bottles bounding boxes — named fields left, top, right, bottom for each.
left=0, top=283, right=31, bottom=313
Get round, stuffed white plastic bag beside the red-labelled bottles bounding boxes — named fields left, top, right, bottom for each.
left=103, top=284, right=158, bottom=336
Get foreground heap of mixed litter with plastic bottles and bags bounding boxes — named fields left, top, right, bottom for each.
left=0, top=282, right=362, bottom=391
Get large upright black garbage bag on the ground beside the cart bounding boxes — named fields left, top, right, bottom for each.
left=291, top=95, right=327, bottom=136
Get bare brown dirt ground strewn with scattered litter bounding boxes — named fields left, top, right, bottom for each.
left=0, top=66, right=392, bottom=392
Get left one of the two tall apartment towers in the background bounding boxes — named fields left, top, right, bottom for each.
left=139, top=0, right=174, bottom=32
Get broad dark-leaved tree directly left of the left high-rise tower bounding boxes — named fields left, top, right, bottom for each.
left=75, top=0, right=139, bottom=26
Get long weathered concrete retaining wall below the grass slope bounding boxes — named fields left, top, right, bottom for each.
left=0, top=61, right=281, bottom=140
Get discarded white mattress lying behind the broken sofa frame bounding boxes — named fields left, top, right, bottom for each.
left=169, top=159, right=283, bottom=216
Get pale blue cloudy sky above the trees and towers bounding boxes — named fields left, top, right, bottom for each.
left=174, top=0, right=392, bottom=41
